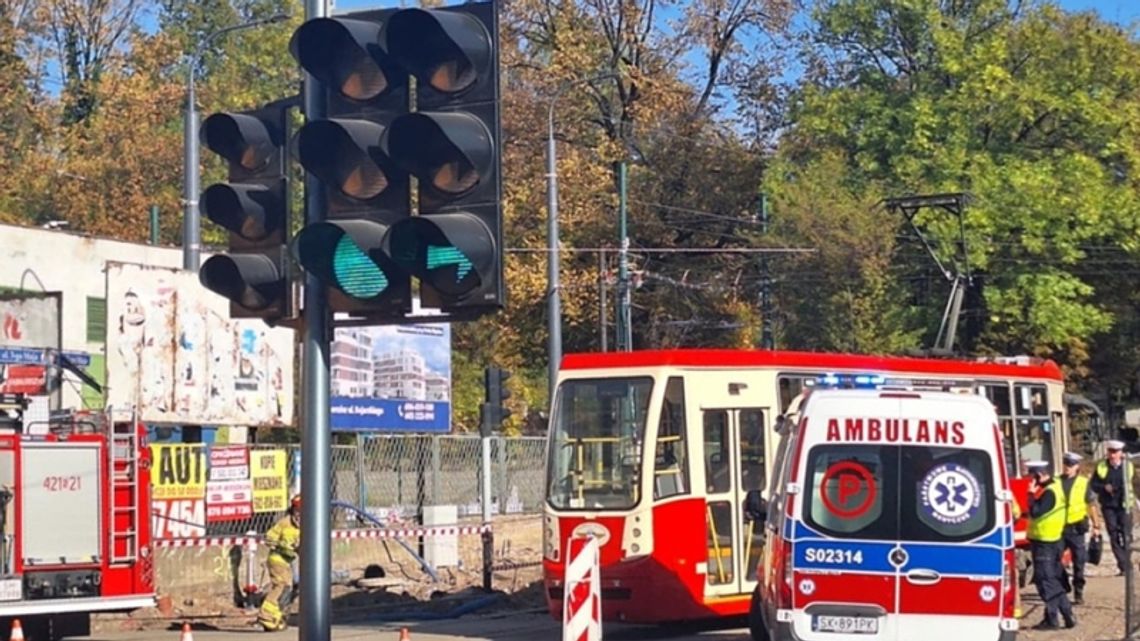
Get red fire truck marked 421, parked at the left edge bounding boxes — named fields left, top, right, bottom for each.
left=0, top=395, right=155, bottom=641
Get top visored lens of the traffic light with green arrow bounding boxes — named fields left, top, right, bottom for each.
left=388, top=9, right=491, bottom=95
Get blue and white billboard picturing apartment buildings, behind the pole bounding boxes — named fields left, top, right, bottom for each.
left=329, top=323, right=451, bottom=432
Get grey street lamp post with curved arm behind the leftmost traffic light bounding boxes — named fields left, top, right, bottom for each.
left=182, top=14, right=290, bottom=271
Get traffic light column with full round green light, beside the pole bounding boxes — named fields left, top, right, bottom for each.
left=291, top=9, right=412, bottom=316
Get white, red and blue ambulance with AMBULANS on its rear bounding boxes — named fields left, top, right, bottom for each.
left=749, top=390, right=1018, bottom=641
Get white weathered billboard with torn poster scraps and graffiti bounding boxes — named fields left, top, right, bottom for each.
left=106, top=262, right=294, bottom=425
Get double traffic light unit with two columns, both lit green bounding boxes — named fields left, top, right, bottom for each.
left=291, top=2, right=504, bottom=317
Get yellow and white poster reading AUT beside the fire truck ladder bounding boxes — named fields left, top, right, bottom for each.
left=150, top=445, right=207, bottom=538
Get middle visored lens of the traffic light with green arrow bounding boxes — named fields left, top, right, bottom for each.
left=386, top=112, right=495, bottom=198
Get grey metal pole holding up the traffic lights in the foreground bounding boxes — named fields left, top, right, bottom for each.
left=300, top=0, right=332, bottom=641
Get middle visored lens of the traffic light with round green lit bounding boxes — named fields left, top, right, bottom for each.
left=298, top=120, right=389, bottom=201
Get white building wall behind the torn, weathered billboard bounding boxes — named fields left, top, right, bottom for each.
left=0, top=225, right=192, bottom=407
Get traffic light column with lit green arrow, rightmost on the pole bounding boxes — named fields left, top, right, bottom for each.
left=386, top=2, right=504, bottom=315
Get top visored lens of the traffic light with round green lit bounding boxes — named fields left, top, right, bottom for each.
left=292, top=18, right=391, bottom=102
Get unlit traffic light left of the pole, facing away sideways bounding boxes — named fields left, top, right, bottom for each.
left=198, top=100, right=296, bottom=325
